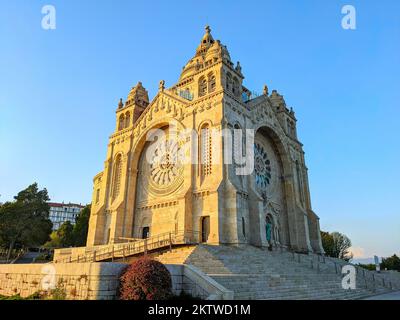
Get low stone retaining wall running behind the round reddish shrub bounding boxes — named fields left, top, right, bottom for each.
left=0, top=262, right=233, bottom=300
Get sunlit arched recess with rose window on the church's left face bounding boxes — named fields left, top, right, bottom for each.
left=132, top=126, right=184, bottom=238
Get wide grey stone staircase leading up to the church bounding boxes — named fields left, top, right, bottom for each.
left=155, top=244, right=394, bottom=300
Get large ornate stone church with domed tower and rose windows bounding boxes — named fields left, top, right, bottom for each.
left=87, top=27, right=323, bottom=253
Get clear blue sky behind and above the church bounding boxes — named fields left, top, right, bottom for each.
left=0, top=0, right=400, bottom=257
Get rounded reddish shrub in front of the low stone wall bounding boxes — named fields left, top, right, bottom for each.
left=119, top=258, right=172, bottom=300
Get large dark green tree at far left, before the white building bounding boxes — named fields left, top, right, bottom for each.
left=0, top=183, right=52, bottom=259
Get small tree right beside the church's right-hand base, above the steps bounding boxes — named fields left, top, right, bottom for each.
left=321, top=231, right=353, bottom=261
